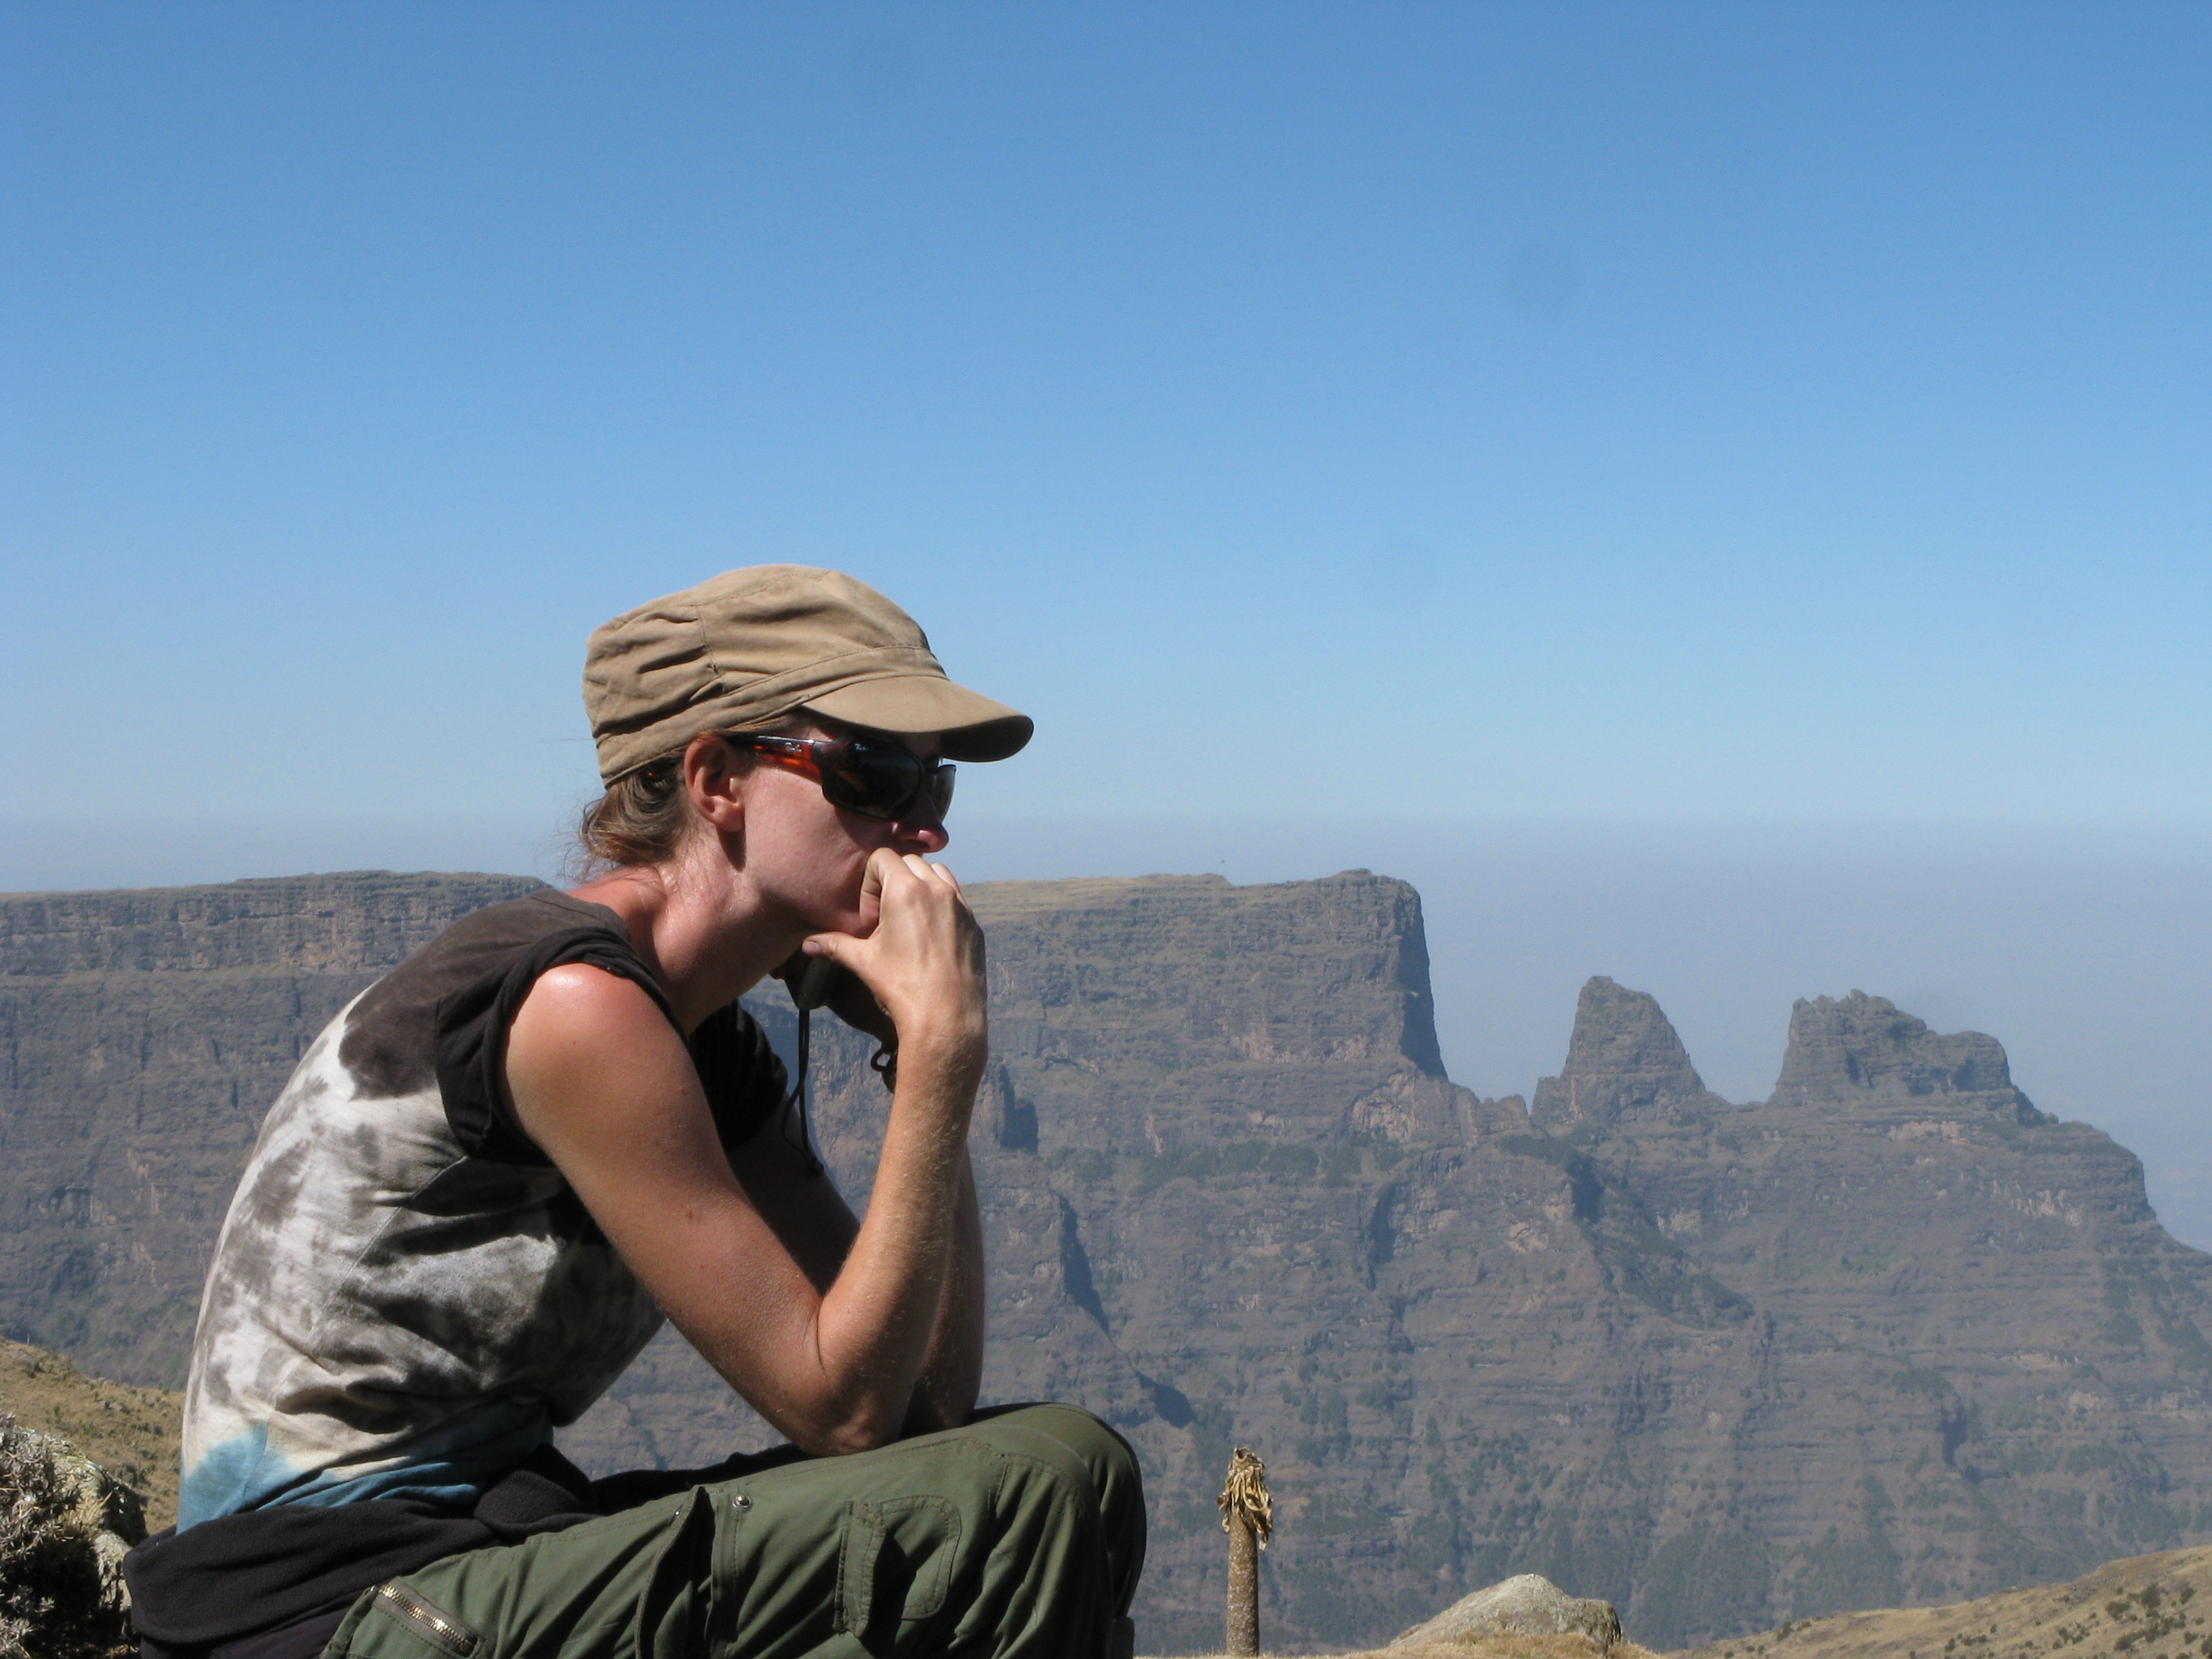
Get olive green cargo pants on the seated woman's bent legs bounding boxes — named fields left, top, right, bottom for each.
left=325, top=1405, right=1143, bottom=1659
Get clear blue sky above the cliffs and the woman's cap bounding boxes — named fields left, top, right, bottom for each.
left=0, top=5, right=2212, bottom=1241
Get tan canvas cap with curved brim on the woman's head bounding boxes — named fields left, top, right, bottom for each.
left=584, top=564, right=1033, bottom=783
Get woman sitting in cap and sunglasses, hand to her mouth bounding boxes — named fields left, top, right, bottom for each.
left=128, top=567, right=1143, bottom=1659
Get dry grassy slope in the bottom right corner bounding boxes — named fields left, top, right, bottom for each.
left=1673, top=1549, right=2212, bottom=1659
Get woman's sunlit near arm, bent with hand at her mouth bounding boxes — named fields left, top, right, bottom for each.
left=506, top=852, right=984, bottom=1453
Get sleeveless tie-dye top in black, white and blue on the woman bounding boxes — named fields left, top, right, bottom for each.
left=177, top=889, right=783, bottom=1531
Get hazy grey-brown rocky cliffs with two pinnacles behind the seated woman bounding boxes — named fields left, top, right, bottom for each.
left=0, top=872, right=2212, bottom=1650
